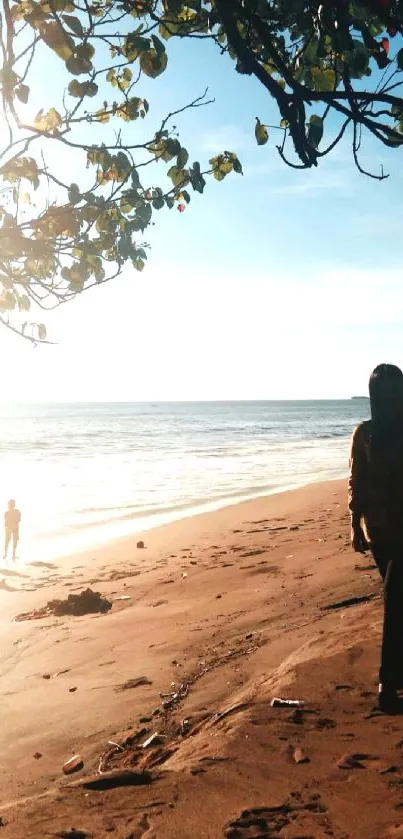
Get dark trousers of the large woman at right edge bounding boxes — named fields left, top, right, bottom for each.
left=371, top=543, right=403, bottom=690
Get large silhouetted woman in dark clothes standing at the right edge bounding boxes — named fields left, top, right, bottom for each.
left=349, top=364, right=403, bottom=713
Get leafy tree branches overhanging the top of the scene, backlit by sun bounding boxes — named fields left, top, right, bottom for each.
left=0, top=0, right=403, bottom=340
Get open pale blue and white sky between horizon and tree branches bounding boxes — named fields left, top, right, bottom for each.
left=0, top=32, right=403, bottom=400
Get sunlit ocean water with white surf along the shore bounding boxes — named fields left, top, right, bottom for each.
left=0, top=400, right=368, bottom=561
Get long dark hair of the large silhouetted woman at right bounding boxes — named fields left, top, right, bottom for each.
left=369, top=364, right=403, bottom=451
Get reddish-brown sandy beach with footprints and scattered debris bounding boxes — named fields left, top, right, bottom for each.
left=0, top=482, right=403, bottom=839
